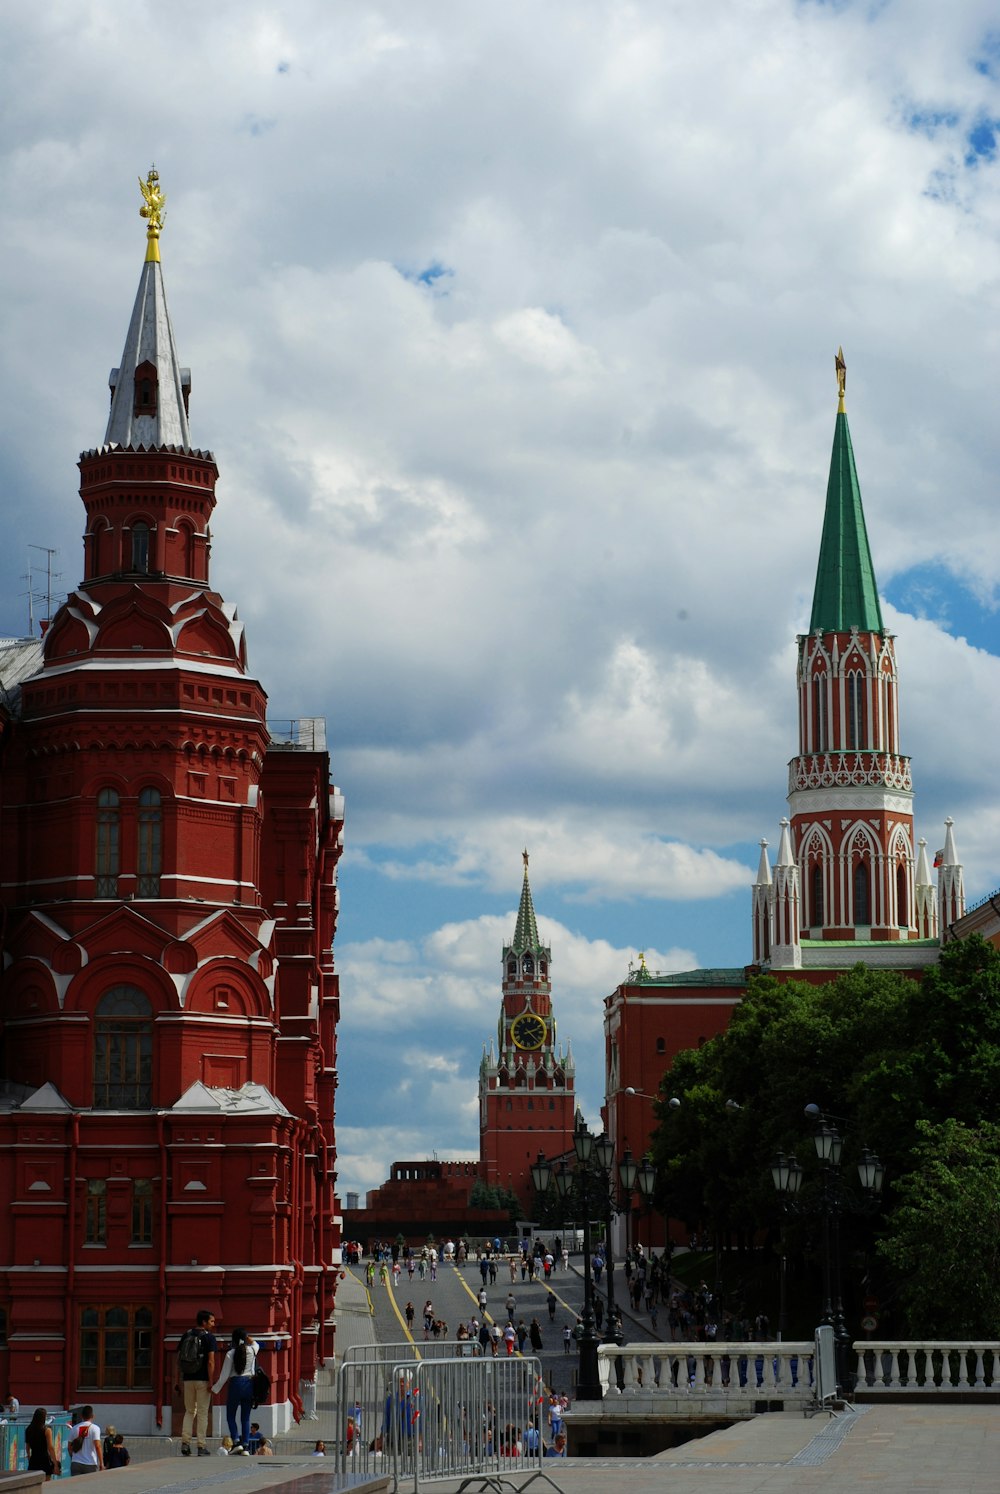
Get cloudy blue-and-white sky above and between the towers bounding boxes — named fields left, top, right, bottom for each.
left=0, top=0, right=1000, bottom=1194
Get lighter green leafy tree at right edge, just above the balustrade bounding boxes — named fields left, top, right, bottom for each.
left=879, top=1121, right=1000, bottom=1339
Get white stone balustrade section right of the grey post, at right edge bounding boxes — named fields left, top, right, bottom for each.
left=852, top=1339, right=1000, bottom=1395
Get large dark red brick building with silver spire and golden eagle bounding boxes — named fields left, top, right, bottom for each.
left=0, top=172, right=344, bottom=1433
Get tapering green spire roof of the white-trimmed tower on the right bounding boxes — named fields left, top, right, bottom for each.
left=809, top=409, right=883, bottom=633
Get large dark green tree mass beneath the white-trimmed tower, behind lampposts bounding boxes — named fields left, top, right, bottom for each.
left=652, top=938, right=1000, bottom=1334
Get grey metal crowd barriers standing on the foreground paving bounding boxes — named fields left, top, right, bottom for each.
left=336, top=1345, right=558, bottom=1494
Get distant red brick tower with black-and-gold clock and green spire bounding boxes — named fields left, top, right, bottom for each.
left=480, top=852, right=575, bottom=1207
